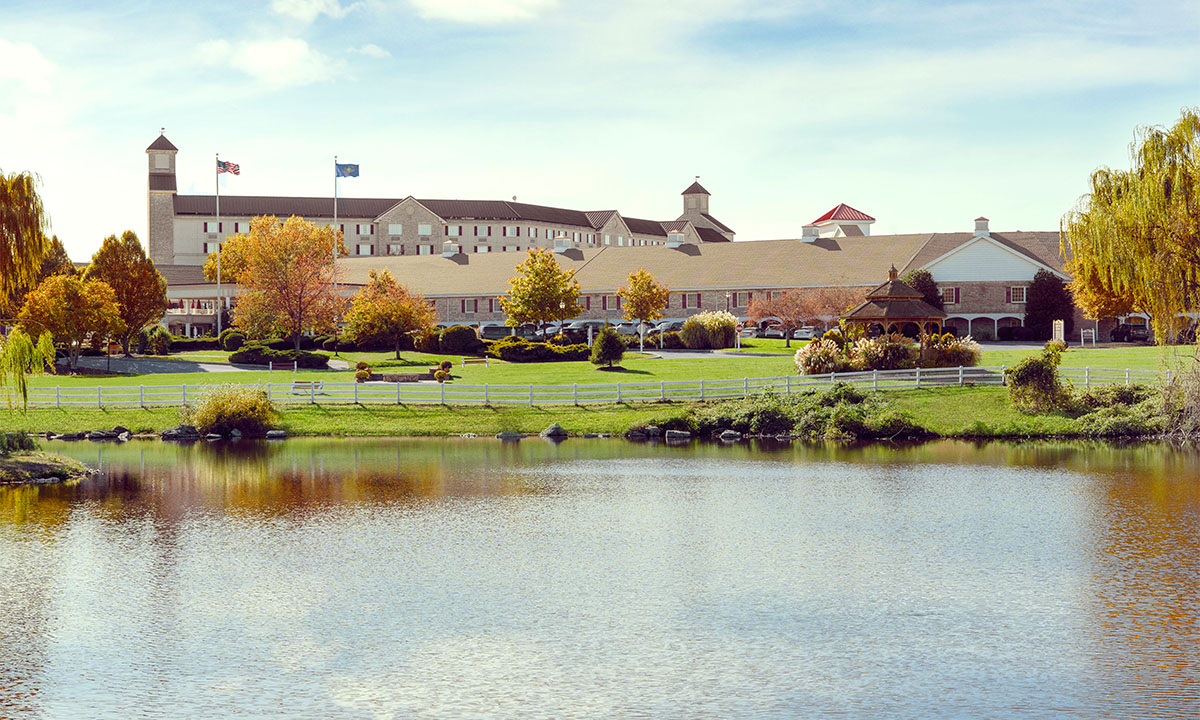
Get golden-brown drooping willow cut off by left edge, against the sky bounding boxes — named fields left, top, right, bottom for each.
left=0, top=173, right=48, bottom=298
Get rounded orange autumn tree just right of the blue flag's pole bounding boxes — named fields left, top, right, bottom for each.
left=346, top=270, right=438, bottom=360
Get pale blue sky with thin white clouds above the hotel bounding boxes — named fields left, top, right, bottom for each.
left=0, top=0, right=1200, bottom=260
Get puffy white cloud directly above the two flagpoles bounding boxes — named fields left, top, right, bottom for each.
left=198, top=37, right=341, bottom=88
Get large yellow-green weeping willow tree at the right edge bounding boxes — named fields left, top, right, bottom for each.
left=1061, top=108, right=1200, bottom=343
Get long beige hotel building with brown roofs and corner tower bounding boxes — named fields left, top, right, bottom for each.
left=146, top=136, right=1105, bottom=338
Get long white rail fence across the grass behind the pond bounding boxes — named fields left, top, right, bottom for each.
left=2, top=366, right=1171, bottom=408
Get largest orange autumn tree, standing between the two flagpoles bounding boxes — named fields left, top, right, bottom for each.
left=231, top=216, right=347, bottom=350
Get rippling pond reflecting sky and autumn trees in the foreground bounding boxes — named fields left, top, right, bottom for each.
left=0, top=439, right=1200, bottom=719
